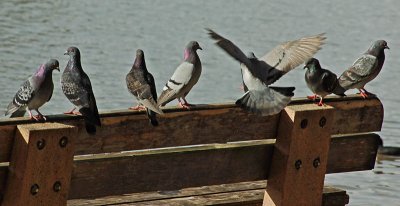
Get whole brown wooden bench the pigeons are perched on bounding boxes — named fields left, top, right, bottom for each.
left=0, top=96, right=383, bottom=206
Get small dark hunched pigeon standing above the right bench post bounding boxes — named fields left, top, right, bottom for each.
left=304, top=58, right=345, bottom=106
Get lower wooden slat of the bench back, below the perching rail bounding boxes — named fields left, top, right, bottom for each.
left=69, top=134, right=380, bottom=198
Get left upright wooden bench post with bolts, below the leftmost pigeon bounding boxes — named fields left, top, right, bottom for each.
left=1, top=123, right=77, bottom=206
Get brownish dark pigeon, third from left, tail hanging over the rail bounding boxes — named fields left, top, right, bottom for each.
left=126, top=49, right=164, bottom=126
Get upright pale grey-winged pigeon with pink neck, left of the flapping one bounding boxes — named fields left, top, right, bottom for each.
left=157, top=41, right=202, bottom=109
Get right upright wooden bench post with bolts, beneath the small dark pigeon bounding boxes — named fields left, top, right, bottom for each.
left=263, top=104, right=335, bottom=206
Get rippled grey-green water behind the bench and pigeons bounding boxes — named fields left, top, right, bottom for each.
left=0, top=0, right=400, bottom=205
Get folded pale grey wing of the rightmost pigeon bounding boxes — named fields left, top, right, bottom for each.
left=339, top=54, right=378, bottom=89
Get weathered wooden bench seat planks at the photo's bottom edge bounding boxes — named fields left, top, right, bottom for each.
left=68, top=181, right=349, bottom=206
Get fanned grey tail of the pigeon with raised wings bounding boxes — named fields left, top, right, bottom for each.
left=236, top=87, right=295, bottom=116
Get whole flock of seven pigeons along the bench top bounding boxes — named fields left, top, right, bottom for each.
left=5, top=29, right=389, bottom=134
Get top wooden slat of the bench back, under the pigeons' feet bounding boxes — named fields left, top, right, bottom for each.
left=0, top=96, right=383, bottom=162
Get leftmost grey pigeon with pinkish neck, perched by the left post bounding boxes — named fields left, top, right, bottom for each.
left=5, top=59, right=60, bottom=121
